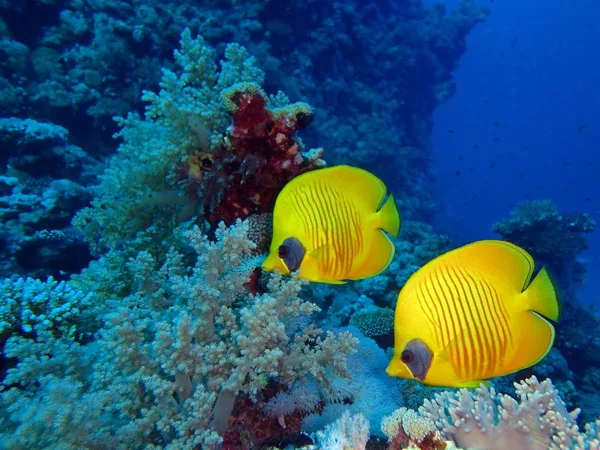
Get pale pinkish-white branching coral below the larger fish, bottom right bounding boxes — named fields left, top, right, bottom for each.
left=420, top=377, right=600, bottom=450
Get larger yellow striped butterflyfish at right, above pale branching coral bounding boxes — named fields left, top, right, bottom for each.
left=387, top=240, right=560, bottom=387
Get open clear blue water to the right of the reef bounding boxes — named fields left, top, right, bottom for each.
left=426, top=0, right=600, bottom=301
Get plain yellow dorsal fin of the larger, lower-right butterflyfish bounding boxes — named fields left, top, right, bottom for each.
left=442, top=240, right=535, bottom=292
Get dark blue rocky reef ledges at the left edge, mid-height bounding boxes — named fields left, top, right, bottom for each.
left=0, top=117, right=97, bottom=279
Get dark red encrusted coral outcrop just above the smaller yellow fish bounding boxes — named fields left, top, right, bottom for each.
left=183, top=83, right=322, bottom=225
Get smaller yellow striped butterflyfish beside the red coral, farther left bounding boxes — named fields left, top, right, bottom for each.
left=262, top=166, right=400, bottom=284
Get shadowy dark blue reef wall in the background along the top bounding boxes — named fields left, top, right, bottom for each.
left=0, top=0, right=487, bottom=225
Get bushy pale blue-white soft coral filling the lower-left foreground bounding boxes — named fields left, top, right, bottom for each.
left=0, top=223, right=356, bottom=448
